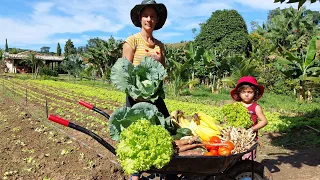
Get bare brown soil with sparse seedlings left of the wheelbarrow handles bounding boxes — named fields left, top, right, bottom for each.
left=0, top=96, right=126, bottom=180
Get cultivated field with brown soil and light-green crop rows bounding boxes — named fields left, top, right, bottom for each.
left=0, top=78, right=320, bottom=180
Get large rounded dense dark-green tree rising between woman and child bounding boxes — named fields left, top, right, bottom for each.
left=195, top=10, right=250, bottom=54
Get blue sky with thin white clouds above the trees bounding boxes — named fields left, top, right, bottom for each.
left=0, top=0, right=320, bottom=52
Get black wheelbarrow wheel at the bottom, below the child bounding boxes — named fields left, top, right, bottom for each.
left=227, top=160, right=264, bottom=180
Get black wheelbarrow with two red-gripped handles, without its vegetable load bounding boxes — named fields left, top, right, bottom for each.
left=48, top=100, right=272, bottom=180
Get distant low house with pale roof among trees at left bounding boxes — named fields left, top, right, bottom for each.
left=5, top=51, right=64, bottom=73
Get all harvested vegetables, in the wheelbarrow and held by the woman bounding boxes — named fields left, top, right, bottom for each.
left=109, top=57, right=255, bottom=174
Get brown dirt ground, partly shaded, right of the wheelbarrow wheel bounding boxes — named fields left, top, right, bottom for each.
left=257, top=135, right=320, bottom=180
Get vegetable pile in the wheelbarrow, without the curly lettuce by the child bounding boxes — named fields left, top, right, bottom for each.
left=109, top=102, right=255, bottom=174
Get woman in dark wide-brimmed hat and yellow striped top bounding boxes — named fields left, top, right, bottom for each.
left=122, top=0, right=170, bottom=117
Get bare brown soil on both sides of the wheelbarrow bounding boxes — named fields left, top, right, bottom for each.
left=0, top=94, right=320, bottom=180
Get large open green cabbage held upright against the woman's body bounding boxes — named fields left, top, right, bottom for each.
left=110, top=57, right=166, bottom=102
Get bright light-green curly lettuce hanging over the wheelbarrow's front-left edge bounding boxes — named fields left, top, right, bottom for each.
left=116, top=119, right=174, bottom=174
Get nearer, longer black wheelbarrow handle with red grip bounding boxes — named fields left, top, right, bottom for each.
left=48, top=114, right=116, bottom=155
